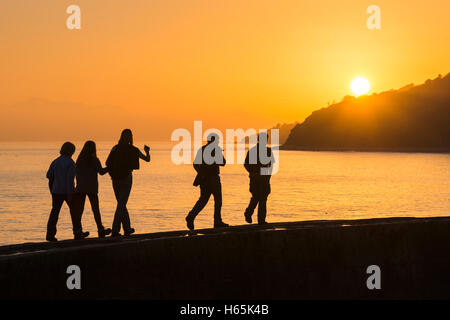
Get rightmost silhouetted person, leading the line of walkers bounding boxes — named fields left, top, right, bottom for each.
left=244, top=132, right=275, bottom=224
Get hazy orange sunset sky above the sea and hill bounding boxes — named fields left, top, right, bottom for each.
left=0, top=0, right=450, bottom=140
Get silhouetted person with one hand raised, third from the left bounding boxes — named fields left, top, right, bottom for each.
left=106, top=129, right=150, bottom=237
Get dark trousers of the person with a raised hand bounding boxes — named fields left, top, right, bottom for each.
left=112, top=174, right=133, bottom=233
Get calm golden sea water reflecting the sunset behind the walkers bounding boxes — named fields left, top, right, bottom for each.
left=0, top=142, right=450, bottom=245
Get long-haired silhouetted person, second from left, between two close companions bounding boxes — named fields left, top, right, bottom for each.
left=74, top=141, right=111, bottom=238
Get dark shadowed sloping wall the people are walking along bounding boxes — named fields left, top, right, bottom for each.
left=0, top=218, right=450, bottom=299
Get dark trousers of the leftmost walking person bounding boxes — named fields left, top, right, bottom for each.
left=47, top=193, right=82, bottom=238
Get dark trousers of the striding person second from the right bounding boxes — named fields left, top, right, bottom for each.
left=188, top=175, right=222, bottom=222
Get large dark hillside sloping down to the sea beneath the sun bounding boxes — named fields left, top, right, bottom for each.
left=282, top=74, right=450, bottom=152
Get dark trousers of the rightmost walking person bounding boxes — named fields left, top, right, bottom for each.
left=245, top=176, right=270, bottom=223
